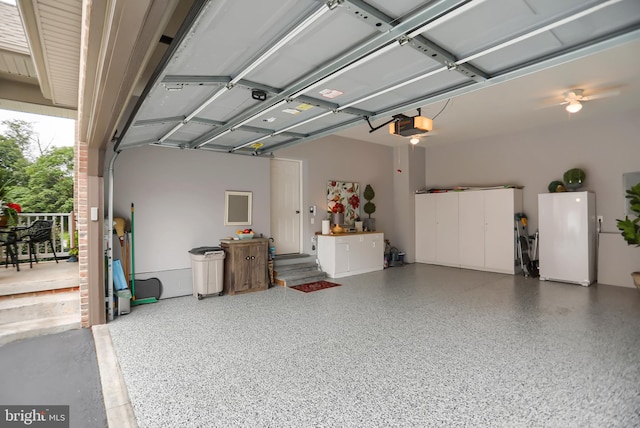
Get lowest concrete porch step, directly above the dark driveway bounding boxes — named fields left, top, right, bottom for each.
left=0, top=313, right=81, bottom=346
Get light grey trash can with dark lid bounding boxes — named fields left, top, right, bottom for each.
left=189, top=247, right=224, bottom=300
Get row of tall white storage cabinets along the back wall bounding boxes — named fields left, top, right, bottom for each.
left=416, top=189, right=522, bottom=274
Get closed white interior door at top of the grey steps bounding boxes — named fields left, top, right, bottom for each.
left=271, top=159, right=302, bottom=254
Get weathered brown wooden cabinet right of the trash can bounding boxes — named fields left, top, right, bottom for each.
left=220, top=238, right=269, bottom=295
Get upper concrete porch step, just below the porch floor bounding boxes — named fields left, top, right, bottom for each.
left=0, top=291, right=80, bottom=328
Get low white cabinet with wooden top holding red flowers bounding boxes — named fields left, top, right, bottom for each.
left=318, top=232, right=384, bottom=278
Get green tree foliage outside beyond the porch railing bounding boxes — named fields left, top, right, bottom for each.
left=0, top=120, right=73, bottom=213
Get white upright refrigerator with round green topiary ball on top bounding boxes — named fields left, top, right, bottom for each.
left=538, top=192, right=596, bottom=287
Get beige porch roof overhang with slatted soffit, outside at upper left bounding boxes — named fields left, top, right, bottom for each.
left=0, top=0, right=82, bottom=119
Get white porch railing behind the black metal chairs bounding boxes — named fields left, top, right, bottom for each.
left=18, top=213, right=76, bottom=260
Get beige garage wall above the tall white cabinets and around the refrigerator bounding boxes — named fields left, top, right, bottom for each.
left=425, top=107, right=640, bottom=287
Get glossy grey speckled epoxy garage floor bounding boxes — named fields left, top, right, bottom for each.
left=109, top=264, right=640, bottom=427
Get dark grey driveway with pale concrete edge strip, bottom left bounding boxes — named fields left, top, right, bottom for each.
left=0, top=325, right=138, bottom=428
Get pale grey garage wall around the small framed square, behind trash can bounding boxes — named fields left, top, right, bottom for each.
left=114, top=147, right=270, bottom=297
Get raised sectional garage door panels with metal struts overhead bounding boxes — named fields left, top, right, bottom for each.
left=116, top=0, right=640, bottom=155
